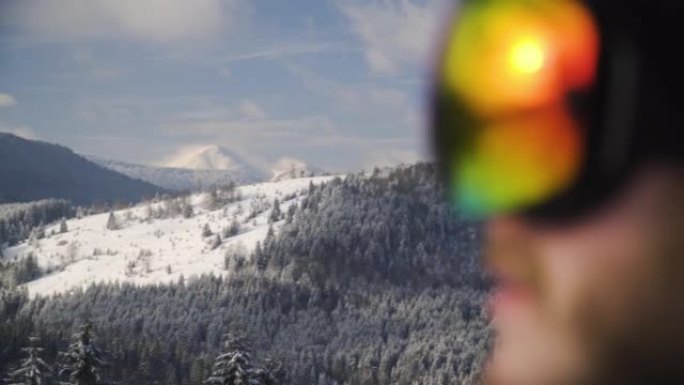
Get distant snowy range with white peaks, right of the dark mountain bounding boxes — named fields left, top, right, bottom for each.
left=85, top=145, right=323, bottom=191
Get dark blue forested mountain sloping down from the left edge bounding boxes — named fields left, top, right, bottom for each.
left=0, top=133, right=165, bottom=205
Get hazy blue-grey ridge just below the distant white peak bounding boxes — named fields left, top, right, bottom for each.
left=86, top=155, right=266, bottom=191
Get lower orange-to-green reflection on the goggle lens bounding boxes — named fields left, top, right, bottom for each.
left=453, top=108, right=582, bottom=214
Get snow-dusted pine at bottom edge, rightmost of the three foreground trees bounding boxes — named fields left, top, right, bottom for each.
left=204, top=334, right=263, bottom=385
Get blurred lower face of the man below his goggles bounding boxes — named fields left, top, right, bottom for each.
left=486, top=168, right=684, bottom=385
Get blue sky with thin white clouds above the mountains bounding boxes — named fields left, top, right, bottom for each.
left=0, top=0, right=449, bottom=171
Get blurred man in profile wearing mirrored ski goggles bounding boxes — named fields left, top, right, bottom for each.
left=433, top=0, right=684, bottom=385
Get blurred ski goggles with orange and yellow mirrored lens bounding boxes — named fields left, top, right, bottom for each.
left=432, top=0, right=636, bottom=218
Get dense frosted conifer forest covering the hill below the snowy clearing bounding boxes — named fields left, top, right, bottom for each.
left=0, top=164, right=491, bottom=385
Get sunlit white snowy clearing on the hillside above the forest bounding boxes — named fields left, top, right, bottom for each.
left=5, top=176, right=340, bottom=295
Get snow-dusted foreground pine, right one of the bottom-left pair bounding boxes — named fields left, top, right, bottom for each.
left=59, top=324, right=105, bottom=385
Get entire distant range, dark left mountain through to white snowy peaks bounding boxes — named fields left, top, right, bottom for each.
left=0, top=133, right=324, bottom=205
